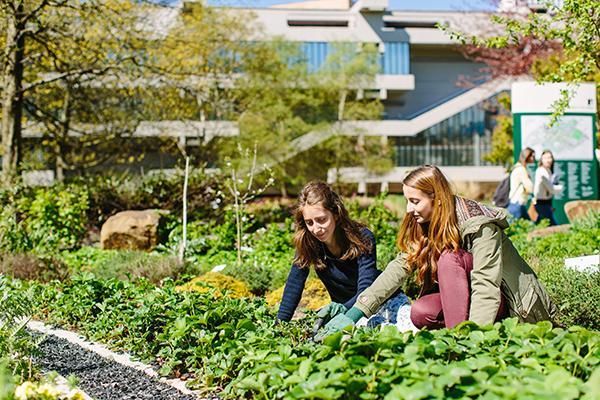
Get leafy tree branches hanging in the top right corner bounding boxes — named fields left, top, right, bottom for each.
left=444, top=0, right=600, bottom=121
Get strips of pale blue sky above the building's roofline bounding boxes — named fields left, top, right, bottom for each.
left=209, top=0, right=497, bottom=10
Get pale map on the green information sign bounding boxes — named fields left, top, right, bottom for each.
left=521, top=115, right=594, bottom=160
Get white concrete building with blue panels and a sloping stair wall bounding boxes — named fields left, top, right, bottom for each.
left=213, top=0, right=537, bottom=191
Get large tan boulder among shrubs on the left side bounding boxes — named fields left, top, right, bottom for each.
left=100, top=210, right=165, bottom=250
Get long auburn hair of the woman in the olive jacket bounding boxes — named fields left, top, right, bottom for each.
left=397, top=165, right=460, bottom=290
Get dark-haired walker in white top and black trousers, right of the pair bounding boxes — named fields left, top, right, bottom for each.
left=533, top=150, right=563, bottom=225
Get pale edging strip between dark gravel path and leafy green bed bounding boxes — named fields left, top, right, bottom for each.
left=27, top=320, right=200, bottom=398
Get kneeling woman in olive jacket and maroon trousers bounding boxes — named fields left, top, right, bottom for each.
left=320, top=165, right=555, bottom=337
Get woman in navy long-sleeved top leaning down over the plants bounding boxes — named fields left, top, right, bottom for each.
left=277, top=182, right=379, bottom=322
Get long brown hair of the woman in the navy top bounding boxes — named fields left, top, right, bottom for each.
left=294, top=181, right=372, bottom=269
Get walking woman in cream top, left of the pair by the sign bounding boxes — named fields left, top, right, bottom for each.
left=506, top=147, right=535, bottom=219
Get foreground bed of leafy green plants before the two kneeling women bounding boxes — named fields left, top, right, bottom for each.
left=12, top=276, right=600, bottom=399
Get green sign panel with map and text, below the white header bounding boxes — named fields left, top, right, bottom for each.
left=513, top=112, right=598, bottom=224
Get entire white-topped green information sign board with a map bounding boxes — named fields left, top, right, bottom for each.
left=511, top=82, right=598, bottom=224
